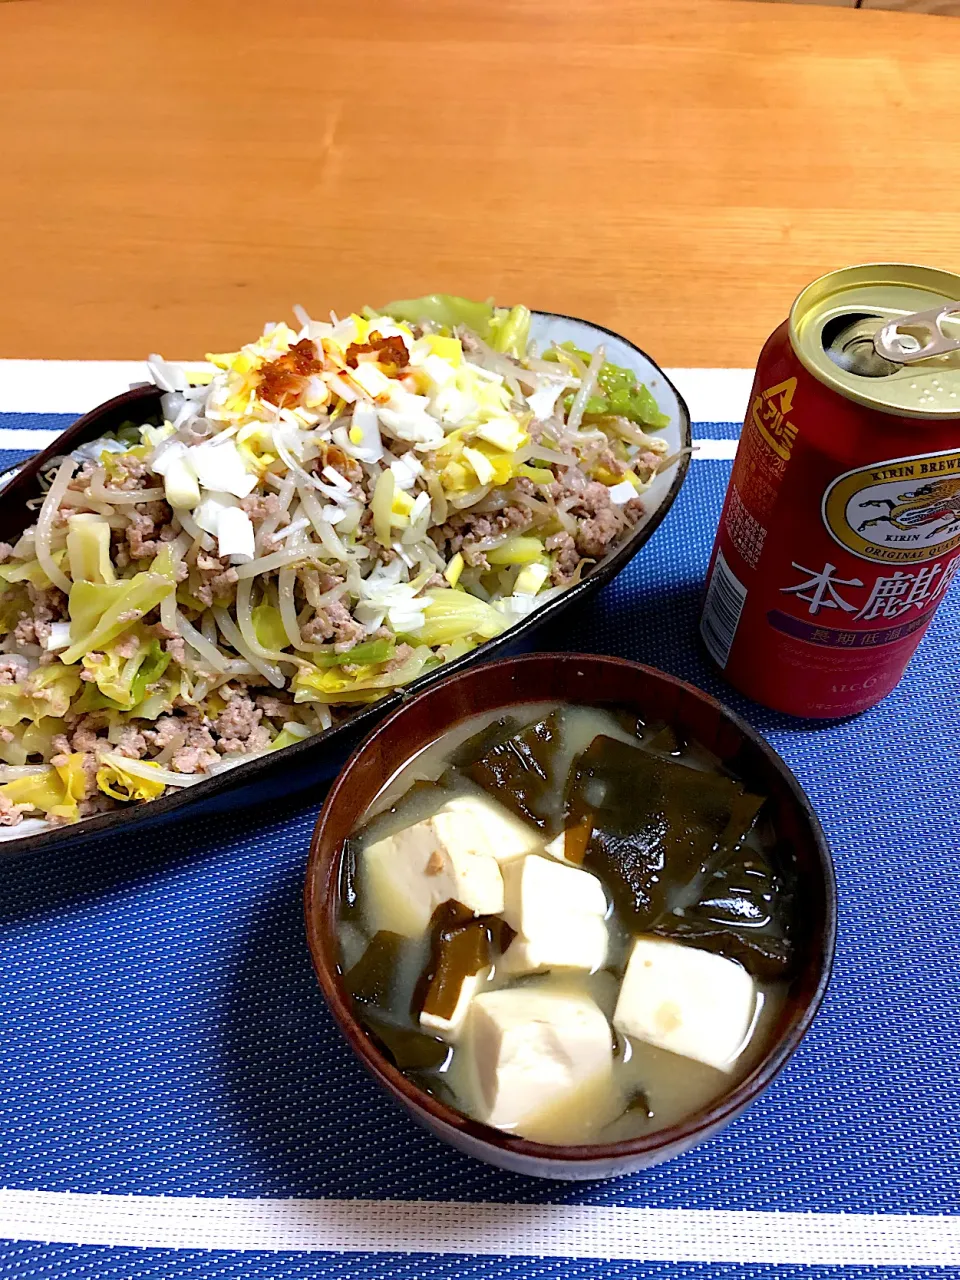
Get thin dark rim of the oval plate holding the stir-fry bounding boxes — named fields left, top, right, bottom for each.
left=0, top=311, right=692, bottom=859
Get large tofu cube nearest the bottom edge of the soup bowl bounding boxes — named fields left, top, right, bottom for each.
left=467, top=987, right=613, bottom=1129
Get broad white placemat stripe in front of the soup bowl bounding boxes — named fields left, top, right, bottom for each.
left=0, top=1189, right=960, bottom=1267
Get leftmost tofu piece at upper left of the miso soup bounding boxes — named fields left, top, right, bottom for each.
left=362, top=814, right=503, bottom=938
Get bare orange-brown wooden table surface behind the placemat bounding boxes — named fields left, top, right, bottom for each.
left=0, top=0, right=960, bottom=365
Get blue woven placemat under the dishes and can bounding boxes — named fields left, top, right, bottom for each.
left=0, top=415, right=960, bottom=1280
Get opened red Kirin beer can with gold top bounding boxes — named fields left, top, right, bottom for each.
left=700, top=264, right=960, bottom=719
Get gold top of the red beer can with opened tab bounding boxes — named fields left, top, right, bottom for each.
left=790, top=262, right=960, bottom=420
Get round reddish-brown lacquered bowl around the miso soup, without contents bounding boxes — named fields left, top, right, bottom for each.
left=305, top=654, right=837, bottom=1179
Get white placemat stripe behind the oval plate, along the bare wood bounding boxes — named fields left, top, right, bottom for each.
left=0, top=360, right=753, bottom=424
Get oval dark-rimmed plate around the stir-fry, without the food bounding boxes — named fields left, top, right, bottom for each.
left=0, top=311, right=690, bottom=856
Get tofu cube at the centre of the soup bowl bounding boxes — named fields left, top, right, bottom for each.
left=503, top=854, right=607, bottom=938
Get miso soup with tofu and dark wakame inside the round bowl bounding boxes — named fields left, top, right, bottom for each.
left=339, top=704, right=792, bottom=1144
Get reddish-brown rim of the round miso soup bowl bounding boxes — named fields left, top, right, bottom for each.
left=303, top=653, right=838, bottom=1166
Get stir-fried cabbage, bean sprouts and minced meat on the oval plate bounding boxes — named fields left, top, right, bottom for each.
left=0, top=294, right=672, bottom=827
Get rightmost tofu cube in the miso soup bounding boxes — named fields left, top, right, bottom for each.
left=613, top=937, right=756, bottom=1071
